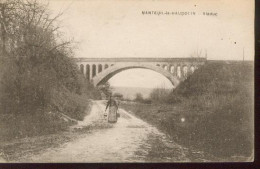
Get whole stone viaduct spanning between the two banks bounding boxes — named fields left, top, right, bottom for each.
left=75, top=58, right=206, bottom=87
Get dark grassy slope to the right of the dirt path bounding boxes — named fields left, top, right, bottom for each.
left=122, top=63, right=253, bottom=158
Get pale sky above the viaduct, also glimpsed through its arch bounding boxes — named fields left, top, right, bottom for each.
left=47, top=0, right=254, bottom=86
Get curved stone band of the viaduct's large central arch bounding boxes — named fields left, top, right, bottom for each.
left=93, top=62, right=180, bottom=87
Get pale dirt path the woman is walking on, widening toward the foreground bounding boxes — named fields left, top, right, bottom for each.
left=1, top=101, right=199, bottom=162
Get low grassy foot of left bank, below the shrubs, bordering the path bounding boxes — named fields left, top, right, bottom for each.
left=0, top=94, right=91, bottom=141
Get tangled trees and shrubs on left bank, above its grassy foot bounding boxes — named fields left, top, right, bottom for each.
left=0, top=0, right=93, bottom=115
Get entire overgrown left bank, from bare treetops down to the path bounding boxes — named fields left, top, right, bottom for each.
left=0, top=0, right=100, bottom=139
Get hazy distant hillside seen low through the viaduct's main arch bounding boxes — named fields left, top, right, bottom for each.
left=112, top=86, right=171, bottom=99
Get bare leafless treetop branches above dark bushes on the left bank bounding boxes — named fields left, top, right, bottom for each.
left=0, top=0, right=72, bottom=57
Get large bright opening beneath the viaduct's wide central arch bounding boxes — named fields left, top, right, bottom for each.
left=108, top=68, right=174, bottom=99
